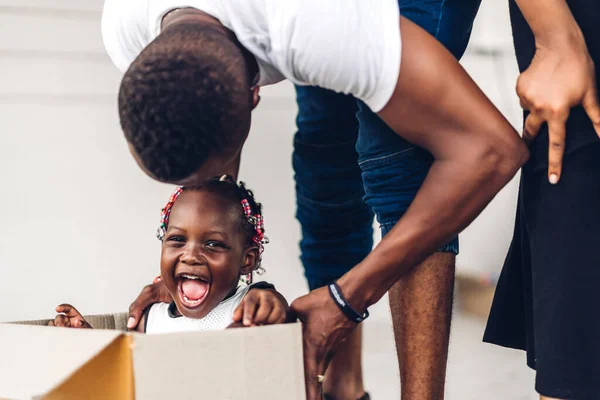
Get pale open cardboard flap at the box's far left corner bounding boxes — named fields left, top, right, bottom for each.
left=0, top=324, right=123, bottom=399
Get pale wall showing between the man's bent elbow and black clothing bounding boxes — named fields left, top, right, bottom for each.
left=457, top=0, right=523, bottom=281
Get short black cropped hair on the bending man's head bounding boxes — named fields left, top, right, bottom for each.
left=119, top=23, right=252, bottom=182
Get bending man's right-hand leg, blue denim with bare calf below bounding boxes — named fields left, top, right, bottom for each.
left=357, top=0, right=480, bottom=400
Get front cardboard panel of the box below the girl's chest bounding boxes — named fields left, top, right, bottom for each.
left=133, top=324, right=306, bottom=400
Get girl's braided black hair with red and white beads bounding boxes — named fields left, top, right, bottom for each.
left=156, top=175, right=269, bottom=281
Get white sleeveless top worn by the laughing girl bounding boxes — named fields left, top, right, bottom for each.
left=146, top=285, right=251, bottom=334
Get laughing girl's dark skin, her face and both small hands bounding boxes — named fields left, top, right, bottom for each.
left=49, top=190, right=288, bottom=331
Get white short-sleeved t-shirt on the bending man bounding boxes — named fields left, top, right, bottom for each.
left=102, top=0, right=401, bottom=112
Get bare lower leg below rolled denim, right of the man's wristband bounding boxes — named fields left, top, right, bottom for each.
left=389, top=252, right=455, bottom=399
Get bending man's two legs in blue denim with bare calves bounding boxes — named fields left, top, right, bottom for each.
left=290, top=0, right=480, bottom=400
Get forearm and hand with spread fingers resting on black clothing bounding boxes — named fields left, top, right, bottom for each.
left=516, top=0, right=600, bottom=184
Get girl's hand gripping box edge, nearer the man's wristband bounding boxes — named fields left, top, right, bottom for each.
left=233, top=289, right=289, bottom=326
